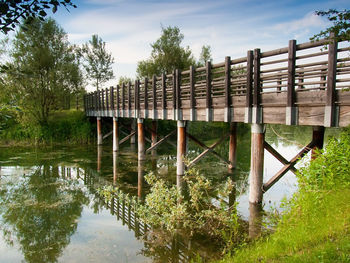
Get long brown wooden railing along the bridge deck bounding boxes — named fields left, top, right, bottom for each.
left=84, top=36, right=350, bottom=126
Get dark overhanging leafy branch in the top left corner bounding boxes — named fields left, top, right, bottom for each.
left=0, top=0, right=76, bottom=34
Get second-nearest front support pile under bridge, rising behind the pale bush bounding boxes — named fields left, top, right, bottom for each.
left=176, top=121, right=186, bottom=179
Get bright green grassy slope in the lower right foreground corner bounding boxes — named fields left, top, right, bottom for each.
left=221, top=131, right=350, bottom=263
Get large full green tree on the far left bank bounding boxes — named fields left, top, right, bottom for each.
left=6, top=19, right=83, bottom=125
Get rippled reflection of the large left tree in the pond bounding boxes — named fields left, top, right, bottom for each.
left=0, top=164, right=89, bottom=262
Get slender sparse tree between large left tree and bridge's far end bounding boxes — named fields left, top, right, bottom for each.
left=82, top=35, right=114, bottom=90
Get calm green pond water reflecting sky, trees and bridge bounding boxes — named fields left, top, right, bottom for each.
left=0, top=126, right=340, bottom=262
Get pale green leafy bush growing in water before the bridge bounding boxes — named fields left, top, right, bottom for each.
left=137, top=168, right=243, bottom=253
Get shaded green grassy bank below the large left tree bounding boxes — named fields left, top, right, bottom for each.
left=0, top=110, right=96, bottom=145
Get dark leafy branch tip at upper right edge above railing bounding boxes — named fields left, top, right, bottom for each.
left=310, top=9, right=350, bottom=41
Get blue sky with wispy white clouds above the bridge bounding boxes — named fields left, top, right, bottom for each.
left=47, top=0, right=350, bottom=89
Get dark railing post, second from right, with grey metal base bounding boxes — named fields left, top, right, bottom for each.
left=286, top=40, right=297, bottom=125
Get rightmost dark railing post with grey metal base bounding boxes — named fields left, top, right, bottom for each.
left=324, top=33, right=338, bottom=127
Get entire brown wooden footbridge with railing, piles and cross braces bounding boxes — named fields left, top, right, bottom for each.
left=84, top=36, right=350, bottom=203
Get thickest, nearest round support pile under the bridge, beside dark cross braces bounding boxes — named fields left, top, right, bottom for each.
left=249, top=124, right=264, bottom=204
